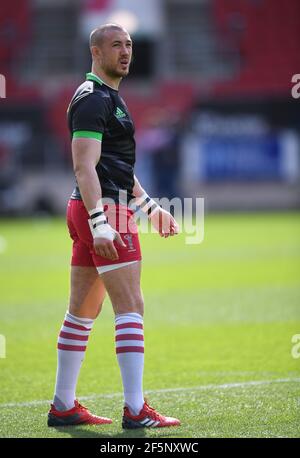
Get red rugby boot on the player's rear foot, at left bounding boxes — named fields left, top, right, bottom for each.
left=48, top=400, right=112, bottom=426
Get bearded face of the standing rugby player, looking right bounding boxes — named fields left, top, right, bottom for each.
left=100, top=30, right=132, bottom=78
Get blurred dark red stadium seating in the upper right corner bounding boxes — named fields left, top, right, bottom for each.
left=214, top=0, right=300, bottom=95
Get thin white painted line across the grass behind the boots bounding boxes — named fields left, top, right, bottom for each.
left=0, top=378, right=300, bottom=408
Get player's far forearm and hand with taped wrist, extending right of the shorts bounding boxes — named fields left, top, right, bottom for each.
left=133, top=176, right=179, bottom=238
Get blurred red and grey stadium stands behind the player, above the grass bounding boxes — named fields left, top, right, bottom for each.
left=0, top=0, right=300, bottom=214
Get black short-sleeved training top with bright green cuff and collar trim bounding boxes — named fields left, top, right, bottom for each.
left=68, top=73, right=135, bottom=202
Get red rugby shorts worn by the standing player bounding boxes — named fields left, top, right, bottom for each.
left=67, top=199, right=142, bottom=267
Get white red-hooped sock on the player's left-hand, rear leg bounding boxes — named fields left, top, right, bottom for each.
left=53, top=312, right=94, bottom=411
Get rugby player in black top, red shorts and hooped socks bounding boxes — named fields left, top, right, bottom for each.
left=48, top=24, right=180, bottom=429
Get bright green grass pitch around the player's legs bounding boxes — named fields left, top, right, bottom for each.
left=0, top=214, right=300, bottom=438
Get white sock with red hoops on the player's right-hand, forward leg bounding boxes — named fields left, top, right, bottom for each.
left=115, top=313, right=144, bottom=415
